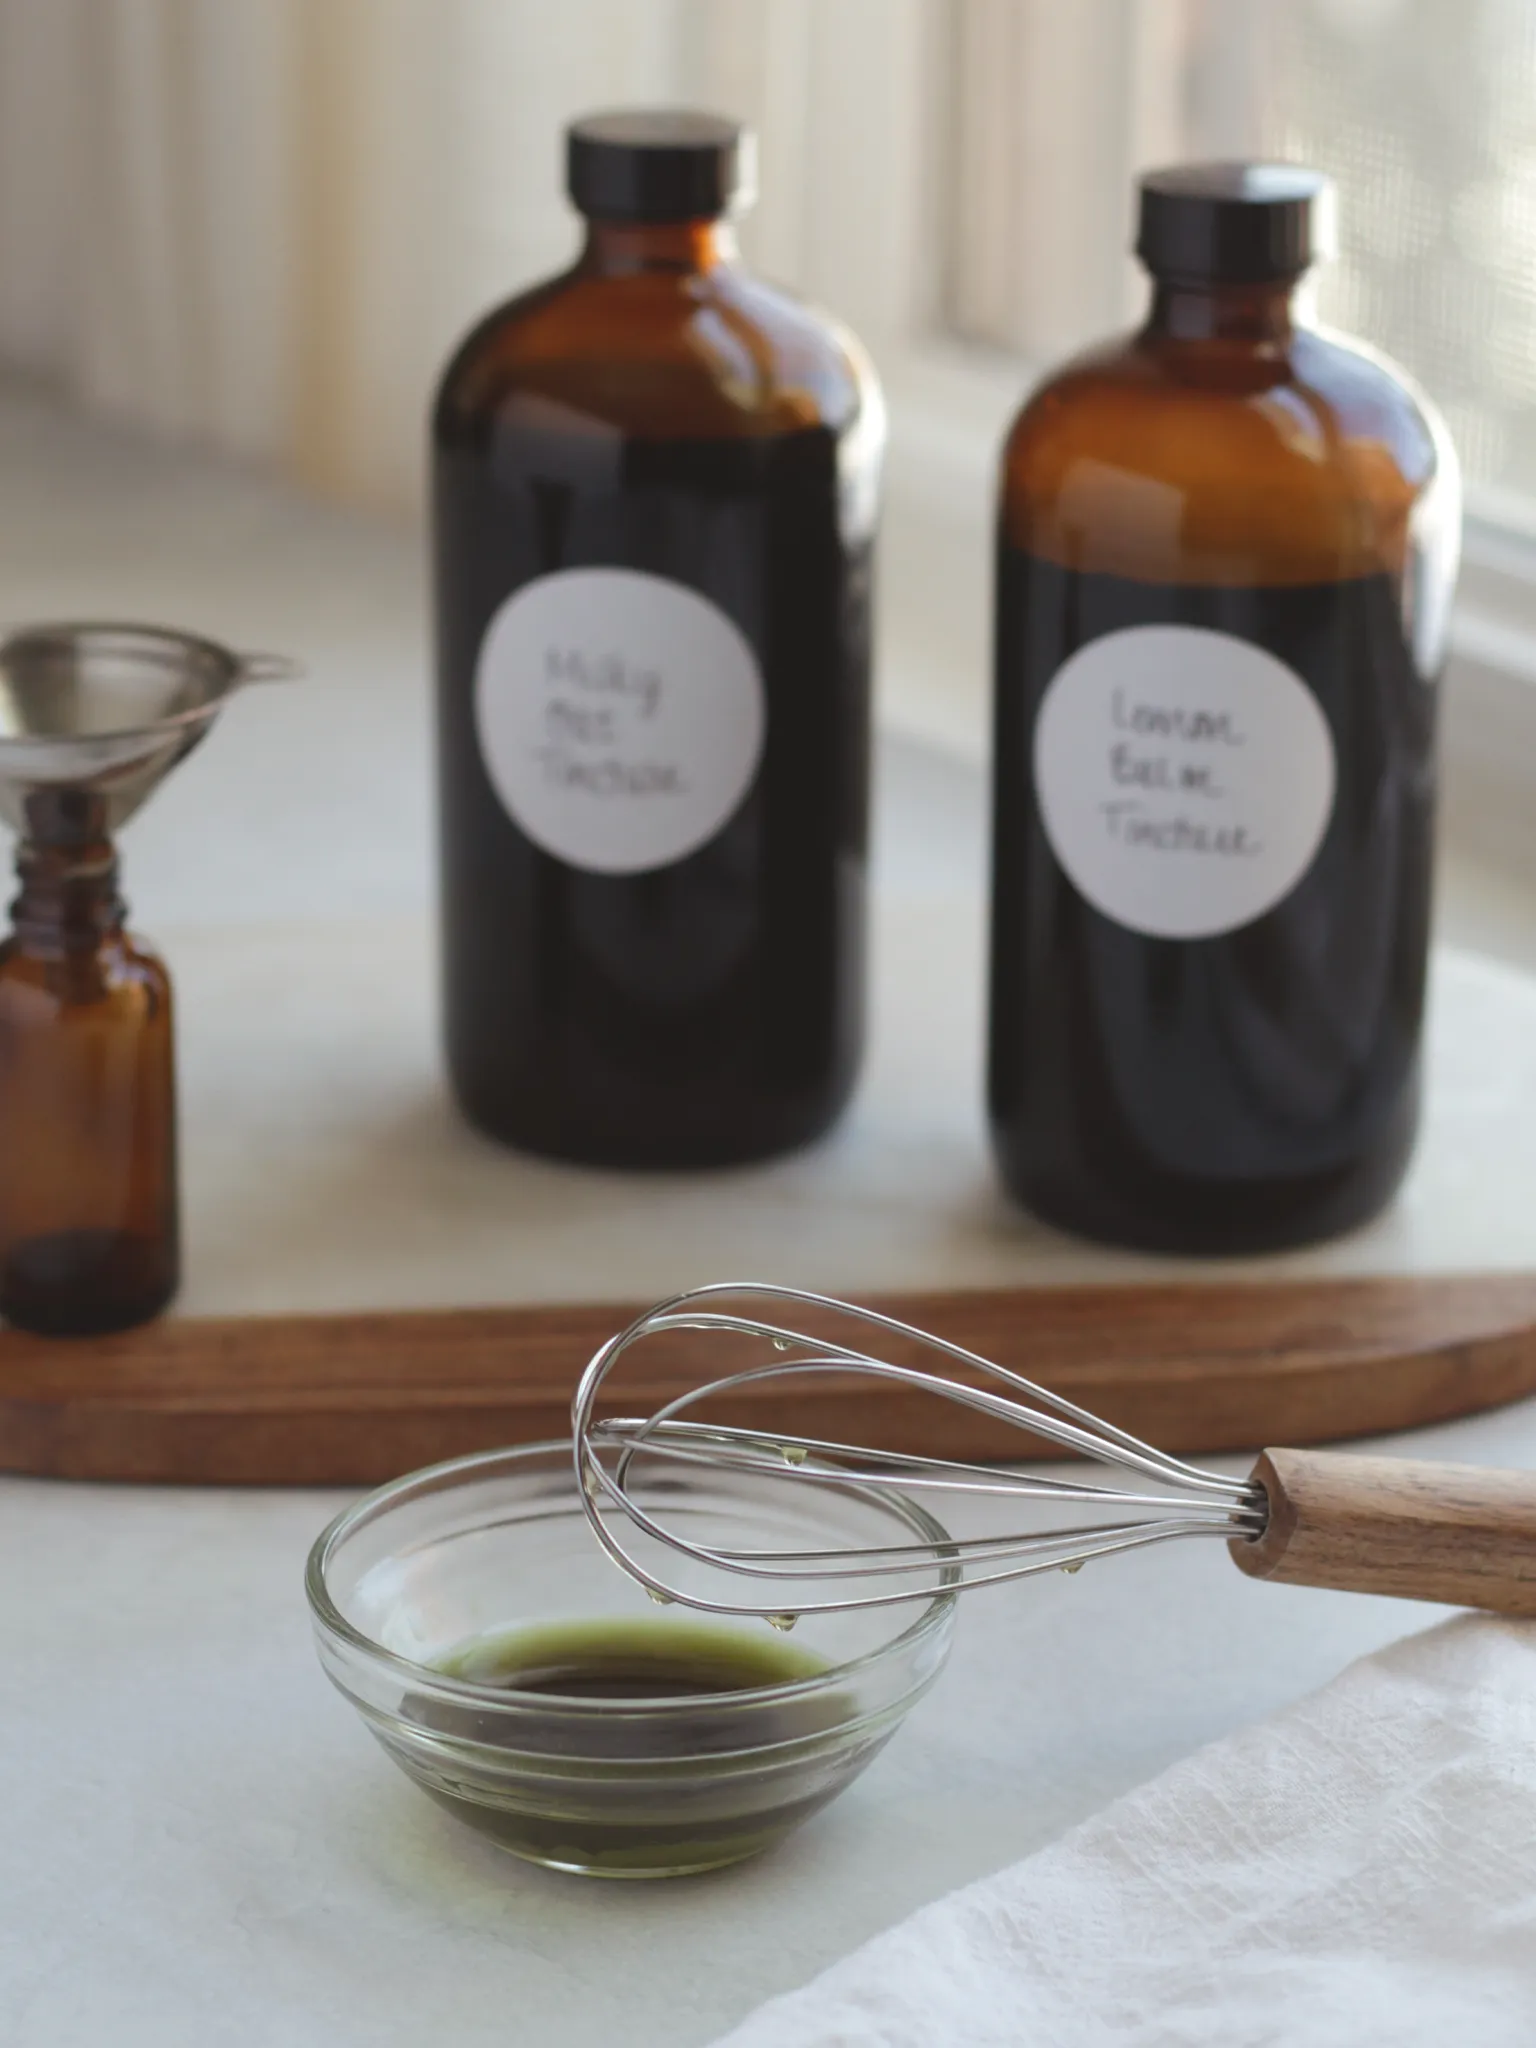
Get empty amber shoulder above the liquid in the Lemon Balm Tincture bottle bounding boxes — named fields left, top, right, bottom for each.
left=999, top=328, right=1460, bottom=584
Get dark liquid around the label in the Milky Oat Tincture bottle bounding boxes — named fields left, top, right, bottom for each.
left=436, top=411, right=870, bottom=1165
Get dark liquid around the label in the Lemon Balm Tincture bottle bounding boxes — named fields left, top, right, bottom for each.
left=989, top=561, right=1434, bottom=1251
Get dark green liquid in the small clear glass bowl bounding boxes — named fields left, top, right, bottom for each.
left=401, top=1618, right=847, bottom=1876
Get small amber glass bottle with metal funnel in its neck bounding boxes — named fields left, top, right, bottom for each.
left=0, top=799, right=178, bottom=1335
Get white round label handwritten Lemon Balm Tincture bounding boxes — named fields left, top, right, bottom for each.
left=1034, top=627, right=1337, bottom=938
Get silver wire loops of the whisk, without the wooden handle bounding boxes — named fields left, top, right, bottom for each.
left=571, top=1282, right=1268, bottom=1624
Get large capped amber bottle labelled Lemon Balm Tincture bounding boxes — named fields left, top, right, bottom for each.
left=989, top=166, right=1460, bottom=1251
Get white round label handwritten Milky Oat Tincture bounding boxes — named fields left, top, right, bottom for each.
left=475, top=569, right=768, bottom=874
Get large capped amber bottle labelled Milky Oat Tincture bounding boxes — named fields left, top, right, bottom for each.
left=434, top=113, right=883, bottom=1165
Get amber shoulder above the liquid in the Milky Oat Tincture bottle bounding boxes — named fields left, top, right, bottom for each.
left=434, top=264, right=881, bottom=444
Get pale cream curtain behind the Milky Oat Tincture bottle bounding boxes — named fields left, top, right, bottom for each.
left=0, top=0, right=948, bottom=506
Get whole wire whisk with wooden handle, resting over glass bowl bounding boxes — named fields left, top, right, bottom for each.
left=571, top=1282, right=1536, bottom=1626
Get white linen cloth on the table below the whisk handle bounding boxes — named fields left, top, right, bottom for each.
left=719, top=1616, right=1536, bottom=2048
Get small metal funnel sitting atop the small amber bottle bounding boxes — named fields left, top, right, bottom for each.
left=0, top=625, right=297, bottom=842
